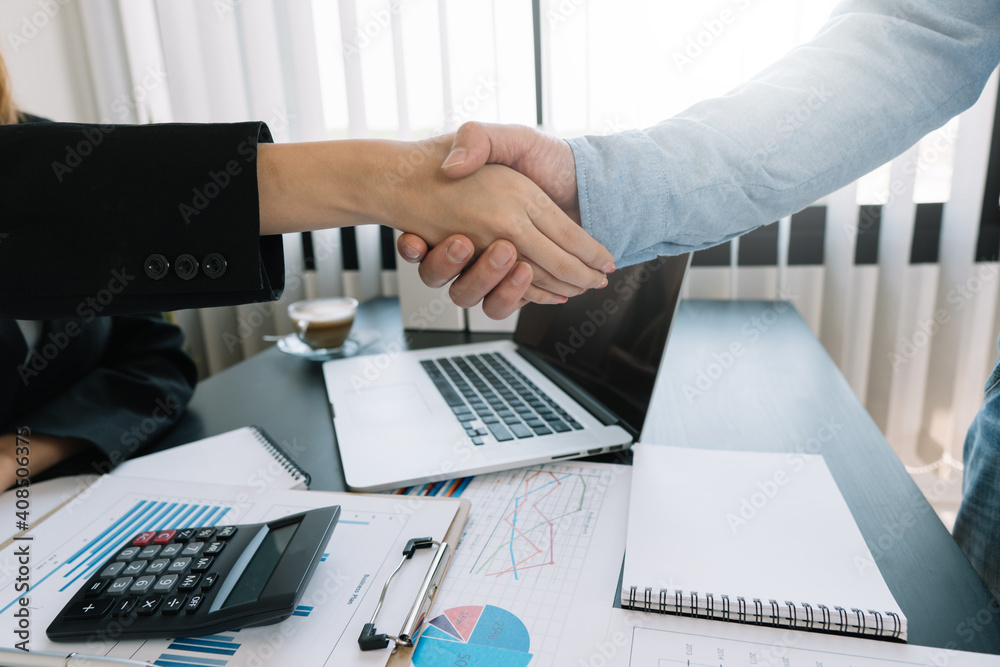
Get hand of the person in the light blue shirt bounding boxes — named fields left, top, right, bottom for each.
left=397, top=122, right=614, bottom=319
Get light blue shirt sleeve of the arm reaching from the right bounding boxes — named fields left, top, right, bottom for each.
left=569, top=0, right=1000, bottom=266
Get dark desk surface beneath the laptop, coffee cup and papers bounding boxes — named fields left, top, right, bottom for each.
left=158, top=299, right=1000, bottom=654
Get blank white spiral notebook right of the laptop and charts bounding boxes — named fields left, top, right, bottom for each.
left=621, top=444, right=906, bottom=641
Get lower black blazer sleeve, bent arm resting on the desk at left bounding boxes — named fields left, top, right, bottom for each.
left=10, top=314, right=197, bottom=465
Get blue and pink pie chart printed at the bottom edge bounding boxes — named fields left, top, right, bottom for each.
left=412, top=605, right=531, bottom=667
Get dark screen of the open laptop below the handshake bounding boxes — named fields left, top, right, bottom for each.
left=514, top=255, right=688, bottom=435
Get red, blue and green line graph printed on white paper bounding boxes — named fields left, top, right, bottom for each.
left=472, top=470, right=589, bottom=580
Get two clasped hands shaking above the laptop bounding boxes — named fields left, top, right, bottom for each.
left=378, top=122, right=615, bottom=319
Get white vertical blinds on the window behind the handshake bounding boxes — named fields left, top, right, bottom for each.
left=81, top=0, right=1000, bottom=520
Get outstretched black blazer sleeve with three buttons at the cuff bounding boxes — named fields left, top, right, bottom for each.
left=0, top=122, right=284, bottom=319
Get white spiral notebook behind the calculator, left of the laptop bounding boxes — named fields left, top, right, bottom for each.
left=112, top=426, right=309, bottom=489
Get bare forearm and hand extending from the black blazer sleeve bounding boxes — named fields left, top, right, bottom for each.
left=257, top=136, right=612, bottom=297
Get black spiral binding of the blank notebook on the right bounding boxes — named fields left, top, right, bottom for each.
left=622, top=586, right=904, bottom=639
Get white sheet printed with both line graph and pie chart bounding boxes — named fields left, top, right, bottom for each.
left=413, top=462, right=630, bottom=667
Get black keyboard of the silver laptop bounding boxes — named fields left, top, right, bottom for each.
left=420, top=352, right=583, bottom=445
